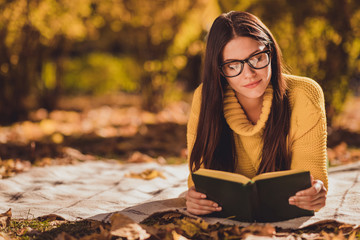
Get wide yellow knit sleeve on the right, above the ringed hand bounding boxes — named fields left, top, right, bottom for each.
left=287, top=76, right=328, bottom=188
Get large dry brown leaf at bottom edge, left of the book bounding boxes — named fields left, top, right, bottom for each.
left=110, top=213, right=150, bottom=240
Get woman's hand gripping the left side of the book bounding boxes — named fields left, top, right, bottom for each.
left=186, top=187, right=221, bottom=215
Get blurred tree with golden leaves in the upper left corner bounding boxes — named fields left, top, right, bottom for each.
left=0, top=0, right=97, bottom=123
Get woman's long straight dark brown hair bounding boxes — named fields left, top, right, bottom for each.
left=190, top=11, right=291, bottom=174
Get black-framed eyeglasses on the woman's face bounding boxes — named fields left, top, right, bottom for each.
left=219, top=50, right=271, bottom=77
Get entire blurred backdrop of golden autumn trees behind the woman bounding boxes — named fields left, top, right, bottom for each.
left=0, top=0, right=360, bottom=123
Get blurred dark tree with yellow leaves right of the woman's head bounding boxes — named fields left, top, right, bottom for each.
left=219, top=0, right=360, bottom=124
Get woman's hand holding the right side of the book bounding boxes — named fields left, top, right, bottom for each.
left=289, top=176, right=327, bottom=210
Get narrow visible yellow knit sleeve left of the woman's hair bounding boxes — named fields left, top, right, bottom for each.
left=186, top=84, right=202, bottom=188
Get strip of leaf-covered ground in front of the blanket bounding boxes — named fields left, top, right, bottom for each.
left=0, top=210, right=360, bottom=240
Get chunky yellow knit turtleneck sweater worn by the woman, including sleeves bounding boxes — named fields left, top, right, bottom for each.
left=187, top=75, right=328, bottom=188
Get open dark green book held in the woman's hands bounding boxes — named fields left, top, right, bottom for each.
left=192, top=169, right=314, bottom=222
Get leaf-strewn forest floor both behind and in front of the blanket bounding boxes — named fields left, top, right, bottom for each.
left=0, top=95, right=360, bottom=239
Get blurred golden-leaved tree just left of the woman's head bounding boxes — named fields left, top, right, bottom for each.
left=101, top=0, right=216, bottom=111
